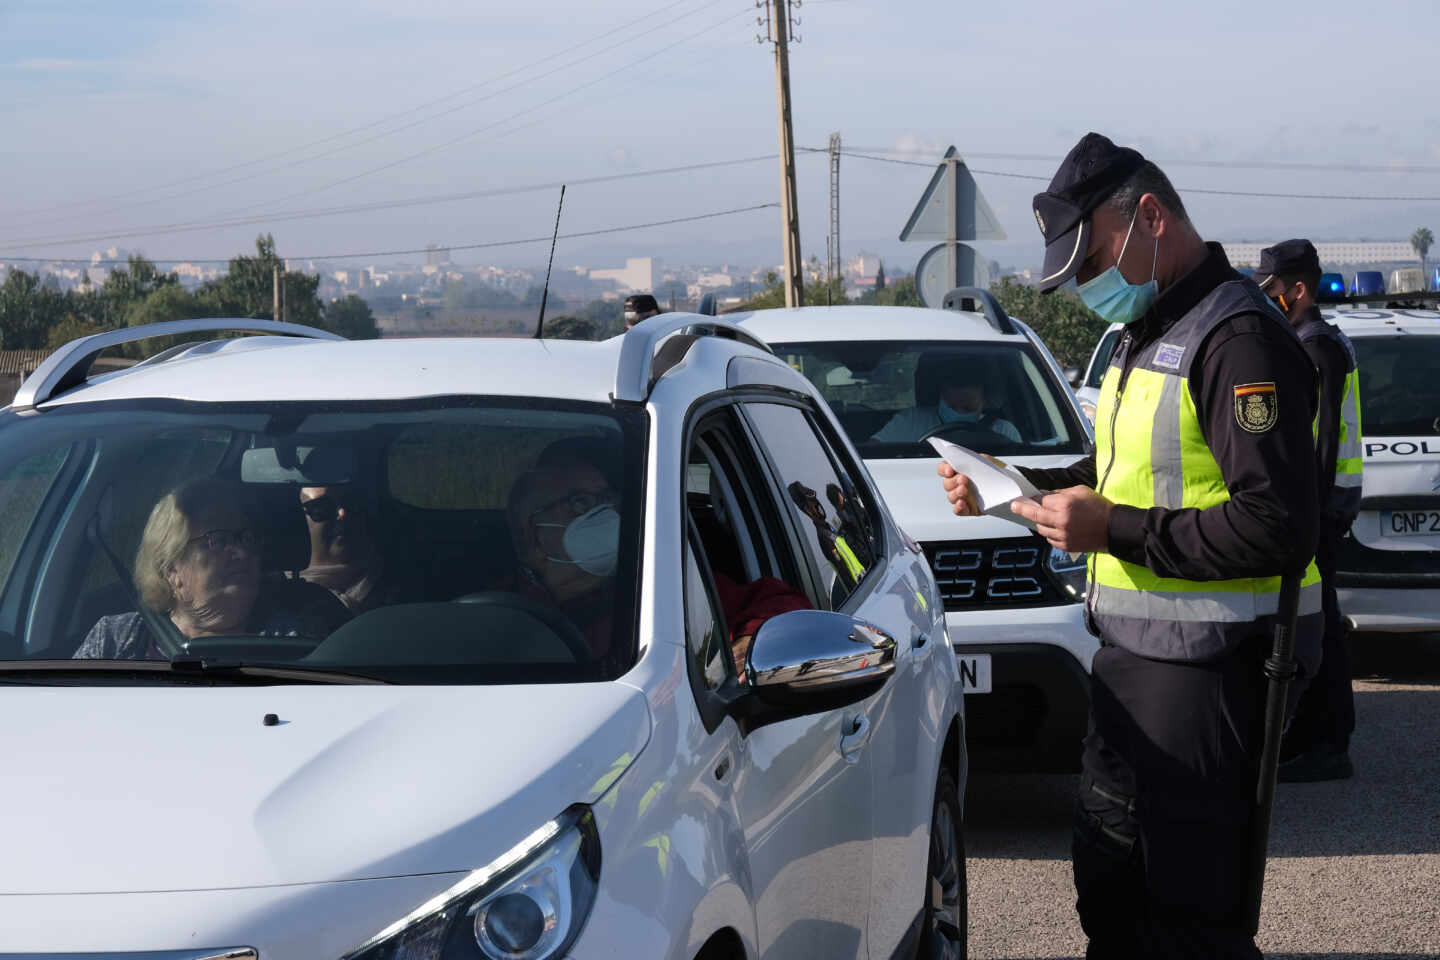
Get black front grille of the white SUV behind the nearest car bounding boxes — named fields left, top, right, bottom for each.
left=920, top=537, right=1074, bottom=610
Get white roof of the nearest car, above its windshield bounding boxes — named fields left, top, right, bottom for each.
left=42, top=337, right=622, bottom=409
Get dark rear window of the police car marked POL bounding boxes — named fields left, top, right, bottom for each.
left=1351, top=334, right=1440, bottom=436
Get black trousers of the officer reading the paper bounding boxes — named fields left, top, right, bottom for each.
left=1073, top=636, right=1270, bottom=960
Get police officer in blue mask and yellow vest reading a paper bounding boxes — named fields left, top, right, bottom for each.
left=939, top=134, right=1320, bottom=957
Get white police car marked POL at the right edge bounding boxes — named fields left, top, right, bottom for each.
left=1076, top=308, right=1440, bottom=632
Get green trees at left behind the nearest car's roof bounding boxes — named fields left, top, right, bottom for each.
left=0, top=233, right=380, bottom=350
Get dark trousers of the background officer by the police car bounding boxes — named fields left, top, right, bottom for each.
left=1284, top=521, right=1355, bottom=756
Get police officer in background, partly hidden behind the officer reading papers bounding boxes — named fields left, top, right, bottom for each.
left=1256, top=240, right=1362, bottom=783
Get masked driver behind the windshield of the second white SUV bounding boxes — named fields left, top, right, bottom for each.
left=870, top=354, right=1020, bottom=443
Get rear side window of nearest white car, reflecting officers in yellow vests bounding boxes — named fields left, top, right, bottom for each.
left=744, top=403, right=877, bottom=607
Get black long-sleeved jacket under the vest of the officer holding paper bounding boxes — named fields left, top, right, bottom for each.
left=1022, top=243, right=1333, bottom=580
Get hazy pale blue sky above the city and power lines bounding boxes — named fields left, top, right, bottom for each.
left=0, top=0, right=1440, bottom=268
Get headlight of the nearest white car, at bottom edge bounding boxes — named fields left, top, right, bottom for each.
left=341, top=807, right=600, bottom=960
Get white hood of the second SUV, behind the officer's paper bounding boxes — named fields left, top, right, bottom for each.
left=865, top=453, right=1080, bottom=543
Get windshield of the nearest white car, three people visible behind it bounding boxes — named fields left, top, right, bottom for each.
left=0, top=397, right=645, bottom=684
